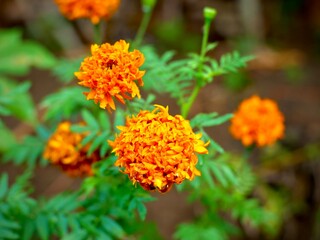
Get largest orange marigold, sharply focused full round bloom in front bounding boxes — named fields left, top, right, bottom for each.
left=109, top=105, right=209, bottom=192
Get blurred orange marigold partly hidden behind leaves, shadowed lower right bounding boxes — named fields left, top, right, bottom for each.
left=43, top=122, right=100, bottom=176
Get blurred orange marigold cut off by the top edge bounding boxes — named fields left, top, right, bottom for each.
left=55, top=0, right=120, bottom=24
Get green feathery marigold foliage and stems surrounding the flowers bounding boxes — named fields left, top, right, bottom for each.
left=0, top=1, right=320, bottom=240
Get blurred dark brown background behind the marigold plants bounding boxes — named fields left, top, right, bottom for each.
left=0, top=0, right=320, bottom=240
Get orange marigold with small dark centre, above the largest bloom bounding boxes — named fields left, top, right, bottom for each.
left=75, top=40, right=144, bottom=110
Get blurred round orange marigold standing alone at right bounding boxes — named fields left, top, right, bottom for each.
left=230, top=96, right=285, bottom=147
